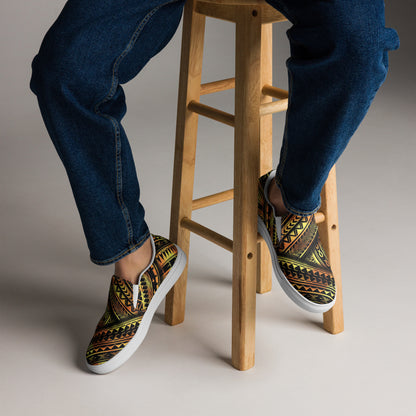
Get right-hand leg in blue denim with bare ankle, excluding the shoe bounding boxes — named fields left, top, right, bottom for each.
left=266, top=0, right=399, bottom=215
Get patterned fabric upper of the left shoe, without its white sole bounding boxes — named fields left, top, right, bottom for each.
left=86, top=235, right=178, bottom=365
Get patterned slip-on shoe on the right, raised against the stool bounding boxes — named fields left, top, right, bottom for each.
left=258, top=171, right=336, bottom=312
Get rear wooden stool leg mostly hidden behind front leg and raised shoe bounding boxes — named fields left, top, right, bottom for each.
left=257, top=23, right=273, bottom=293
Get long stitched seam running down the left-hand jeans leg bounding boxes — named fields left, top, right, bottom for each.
left=94, top=0, right=177, bottom=245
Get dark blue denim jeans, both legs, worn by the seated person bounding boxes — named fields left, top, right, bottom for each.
left=30, top=0, right=399, bottom=265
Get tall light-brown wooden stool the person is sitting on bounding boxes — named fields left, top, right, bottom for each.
left=165, top=0, right=343, bottom=370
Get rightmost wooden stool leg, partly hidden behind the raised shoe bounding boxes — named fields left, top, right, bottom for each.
left=318, top=166, right=344, bottom=334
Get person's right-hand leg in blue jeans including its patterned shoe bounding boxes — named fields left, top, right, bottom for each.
left=258, top=0, right=399, bottom=312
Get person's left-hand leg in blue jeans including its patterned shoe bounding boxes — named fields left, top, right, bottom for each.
left=31, top=0, right=186, bottom=374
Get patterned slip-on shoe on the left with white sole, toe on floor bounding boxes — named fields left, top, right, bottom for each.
left=86, top=235, right=186, bottom=374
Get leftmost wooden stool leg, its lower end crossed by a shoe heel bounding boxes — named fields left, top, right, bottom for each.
left=165, top=0, right=205, bottom=325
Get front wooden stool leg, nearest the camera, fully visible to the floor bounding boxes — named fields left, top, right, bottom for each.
left=232, top=6, right=261, bottom=370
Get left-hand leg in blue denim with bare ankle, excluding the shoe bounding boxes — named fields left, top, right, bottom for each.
left=30, top=0, right=185, bottom=278
